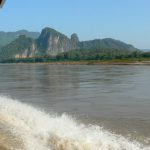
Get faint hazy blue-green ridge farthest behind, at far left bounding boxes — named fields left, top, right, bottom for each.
left=0, top=30, right=40, bottom=48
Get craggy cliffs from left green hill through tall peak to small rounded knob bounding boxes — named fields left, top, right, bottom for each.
left=0, top=27, right=79, bottom=58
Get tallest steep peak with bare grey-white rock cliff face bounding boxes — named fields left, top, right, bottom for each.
left=36, top=28, right=78, bottom=55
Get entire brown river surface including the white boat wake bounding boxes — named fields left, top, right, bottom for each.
left=0, top=64, right=150, bottom=150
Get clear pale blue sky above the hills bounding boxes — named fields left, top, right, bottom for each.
left=0, top=0, right=150, bottom=48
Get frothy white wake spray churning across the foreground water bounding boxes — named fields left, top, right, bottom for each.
left=0, top=96, right=150, bottom=150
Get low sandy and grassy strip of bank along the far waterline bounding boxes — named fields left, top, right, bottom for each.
left=1, top=58, right=150, bottom=65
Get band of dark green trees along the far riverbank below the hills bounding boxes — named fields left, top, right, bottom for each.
left=1, top=49, right=150, bottom=64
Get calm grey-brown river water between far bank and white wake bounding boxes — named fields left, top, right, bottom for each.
left=0, top=64, right=150, bottom=143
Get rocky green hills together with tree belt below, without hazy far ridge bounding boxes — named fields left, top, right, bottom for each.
left=0, top=27, right=150, bottom=63
